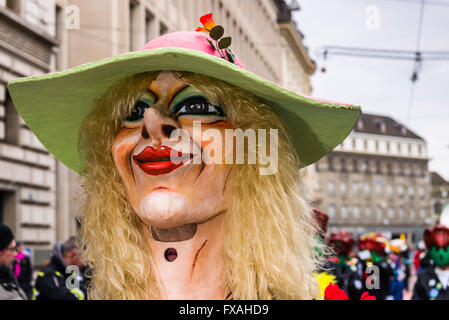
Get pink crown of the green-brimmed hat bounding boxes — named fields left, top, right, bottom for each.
left=140, top=31, right=246, bottom=69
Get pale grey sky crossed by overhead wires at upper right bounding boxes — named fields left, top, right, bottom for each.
left=294, top=0, right=449, bottom=179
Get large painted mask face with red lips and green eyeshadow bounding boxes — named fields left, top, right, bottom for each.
left=112, top=71, right=232, bottom=235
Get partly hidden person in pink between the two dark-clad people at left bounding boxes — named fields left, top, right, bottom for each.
left=12, top=241, right=33, bottom=299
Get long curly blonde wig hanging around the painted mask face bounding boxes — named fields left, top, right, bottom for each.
left=79, top=72, right=322, bottom=299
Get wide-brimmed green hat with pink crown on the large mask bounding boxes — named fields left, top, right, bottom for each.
left=8, top=32, right=361, bottom=172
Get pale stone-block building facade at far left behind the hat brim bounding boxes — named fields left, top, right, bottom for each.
left=0, top=0, right=60, bottom=264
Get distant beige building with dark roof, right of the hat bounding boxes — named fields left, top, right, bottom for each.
left=316, top=114, right=434, bottom=240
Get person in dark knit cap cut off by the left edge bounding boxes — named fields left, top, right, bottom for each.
left=0, top=223, right=28, bottom=300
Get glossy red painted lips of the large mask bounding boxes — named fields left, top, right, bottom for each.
left=133, top=146, right=193, bottom=176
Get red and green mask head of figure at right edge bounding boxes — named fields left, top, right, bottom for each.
left=424, top=225, right=449, bottom=266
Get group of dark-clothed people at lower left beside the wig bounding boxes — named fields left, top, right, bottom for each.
left=0, top=224, right=87, bottom=300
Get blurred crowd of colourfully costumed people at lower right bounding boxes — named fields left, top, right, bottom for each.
left=314, top=210, right=449, bottom=300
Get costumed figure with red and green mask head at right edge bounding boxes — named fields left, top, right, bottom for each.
left=412, top=225, right=449, bottom=300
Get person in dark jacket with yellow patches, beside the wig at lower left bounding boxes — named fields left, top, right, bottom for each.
left=33, top=237, right=87, bottom=300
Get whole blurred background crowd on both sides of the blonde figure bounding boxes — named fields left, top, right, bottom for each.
left=0, top=218, right=449, bottom=300
